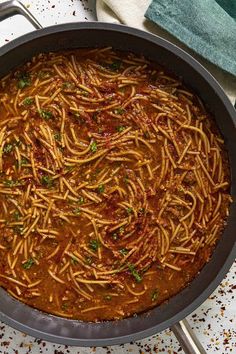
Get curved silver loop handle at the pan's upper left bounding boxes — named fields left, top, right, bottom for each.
left=0, top=0, right=42, bottom=29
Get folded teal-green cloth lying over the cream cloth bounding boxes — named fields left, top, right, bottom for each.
left=145, top=0, right=236, bottom=75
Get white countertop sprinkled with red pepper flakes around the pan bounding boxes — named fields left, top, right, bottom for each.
left=0, top=0, right=236, bottom=354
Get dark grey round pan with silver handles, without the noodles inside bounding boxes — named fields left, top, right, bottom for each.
left=0, top=0, right=236, bottom=354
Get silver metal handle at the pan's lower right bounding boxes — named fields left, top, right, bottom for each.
left=171, top=319, right=206, bottom=354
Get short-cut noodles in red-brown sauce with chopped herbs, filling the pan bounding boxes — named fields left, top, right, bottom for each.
left=0, top=48, right=231, bottom=321
